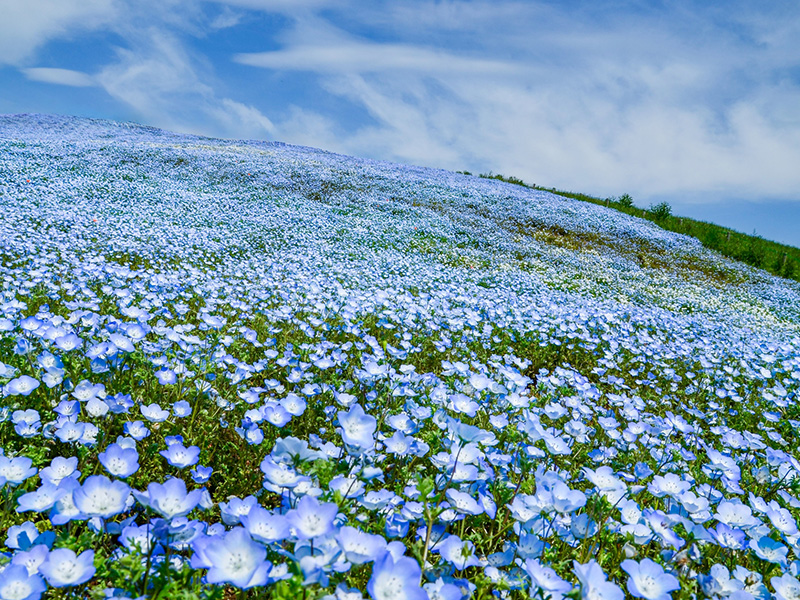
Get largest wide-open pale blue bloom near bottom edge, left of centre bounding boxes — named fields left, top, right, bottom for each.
left=191, top=527, right=272, bottom=589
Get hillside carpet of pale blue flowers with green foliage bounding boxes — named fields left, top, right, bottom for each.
left=0, top=116, right=800, bottom=600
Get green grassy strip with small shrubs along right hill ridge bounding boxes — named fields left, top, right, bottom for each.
left=472, top=173, right=800, bottom=281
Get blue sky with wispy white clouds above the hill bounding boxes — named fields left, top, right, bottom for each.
left=0, top=0, right=800, bottom=246
